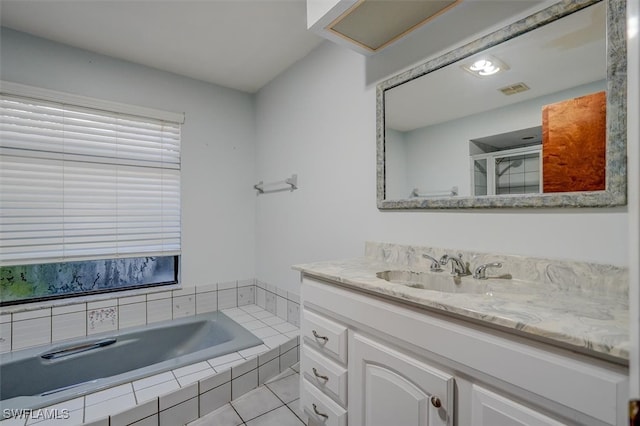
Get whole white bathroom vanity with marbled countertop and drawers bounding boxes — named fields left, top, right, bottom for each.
left=295, top=243, right=629, bottom=426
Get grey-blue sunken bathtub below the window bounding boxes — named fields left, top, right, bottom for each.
left=0, top=312, right=262, bottom=412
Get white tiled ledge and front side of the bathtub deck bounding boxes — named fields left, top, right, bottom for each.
left=0, top=304, right=299, bottom=426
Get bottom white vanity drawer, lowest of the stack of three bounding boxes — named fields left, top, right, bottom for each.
left=300, top=379, right=347, bottom=426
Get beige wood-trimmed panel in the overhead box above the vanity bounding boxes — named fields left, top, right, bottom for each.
left=327, top=0, right=462, bottom=52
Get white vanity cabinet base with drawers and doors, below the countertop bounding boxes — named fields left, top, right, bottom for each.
left=300, top=275, right=628, bottom=426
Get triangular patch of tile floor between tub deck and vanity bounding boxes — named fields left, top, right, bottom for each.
left=188, top=364, right=306, bottom=426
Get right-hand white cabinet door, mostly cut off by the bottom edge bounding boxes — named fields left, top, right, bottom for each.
left=471, top=385, right=564, bottom=426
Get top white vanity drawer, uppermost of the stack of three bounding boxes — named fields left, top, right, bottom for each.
left=302, top=309, right=347, bottom=364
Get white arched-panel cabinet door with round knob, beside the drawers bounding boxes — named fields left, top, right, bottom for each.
left=348, top=333, right=454, bottom=426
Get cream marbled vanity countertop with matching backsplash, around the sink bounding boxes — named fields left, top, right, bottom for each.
left=294, top=242, right=629, bottom=364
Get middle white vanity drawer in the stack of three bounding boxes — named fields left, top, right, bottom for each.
left=300, top=345, right=347, bottom=406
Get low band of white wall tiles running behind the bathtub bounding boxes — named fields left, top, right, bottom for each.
left=0, top=279, right=300, bottom=353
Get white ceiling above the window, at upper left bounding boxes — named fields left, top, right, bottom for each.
left=0, top=0, right=322, bottom=93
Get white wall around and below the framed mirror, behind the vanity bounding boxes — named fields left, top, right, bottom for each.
left=256, top=42, right=624, bottom=291
